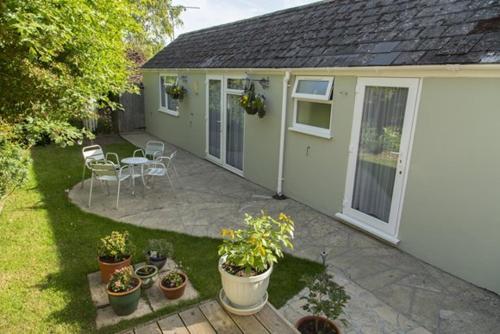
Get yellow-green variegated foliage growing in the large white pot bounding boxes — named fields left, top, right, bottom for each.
left=219, top=212, right=294, bottom=276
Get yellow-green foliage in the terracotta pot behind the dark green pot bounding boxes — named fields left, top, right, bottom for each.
left=97, top=231, right=134, bottom=262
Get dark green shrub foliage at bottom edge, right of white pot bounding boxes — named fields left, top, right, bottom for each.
left=301, top=271, right=350, bottom=333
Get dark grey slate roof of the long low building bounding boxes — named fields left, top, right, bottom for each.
left=143, top=0, right=500, bottom=68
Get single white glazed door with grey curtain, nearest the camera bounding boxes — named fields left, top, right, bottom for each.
left=340, top=78, right=419, bottom=243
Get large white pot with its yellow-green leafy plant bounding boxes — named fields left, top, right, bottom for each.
left=219, top=213, right=294, bottom=312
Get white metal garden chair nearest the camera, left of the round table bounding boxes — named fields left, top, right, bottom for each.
left=87, top=160, right=130, bottom=209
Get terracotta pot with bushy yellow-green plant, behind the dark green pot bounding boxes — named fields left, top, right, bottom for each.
left=97, top=231, right=134, bottom=283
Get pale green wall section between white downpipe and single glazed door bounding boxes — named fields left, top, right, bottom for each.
left=283, top=76, right=356, bottom=216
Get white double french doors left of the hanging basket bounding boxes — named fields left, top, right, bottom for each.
left=206, top=75, right=245, bottom=175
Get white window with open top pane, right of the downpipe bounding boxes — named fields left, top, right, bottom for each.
left=290, top=77, right=333, bottom=138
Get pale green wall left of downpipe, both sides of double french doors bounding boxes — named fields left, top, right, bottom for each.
left=144, top=72, right=283, bottom=190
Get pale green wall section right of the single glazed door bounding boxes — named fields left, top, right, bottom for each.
left=400, top=78, right=500, bottom=293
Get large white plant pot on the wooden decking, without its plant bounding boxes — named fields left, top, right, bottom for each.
left=219, top=256, right=273, bottom=308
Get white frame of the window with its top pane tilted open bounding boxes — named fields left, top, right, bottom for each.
left=289, top=76, right=334, bottom=139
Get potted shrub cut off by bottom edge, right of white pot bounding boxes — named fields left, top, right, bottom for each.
left=296, top=271, right=350, bottom=334
